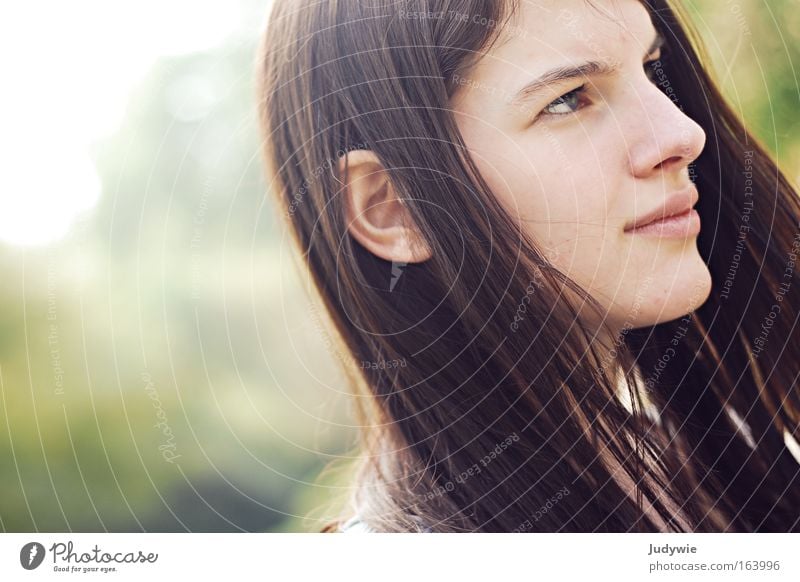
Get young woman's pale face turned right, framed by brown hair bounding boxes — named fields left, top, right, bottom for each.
left=451, top=0, right=711, bottom=328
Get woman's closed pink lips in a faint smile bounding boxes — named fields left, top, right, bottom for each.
left=625, top=184, right=700, bottom=237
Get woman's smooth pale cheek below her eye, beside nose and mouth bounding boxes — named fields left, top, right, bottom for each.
left=462, top=125, right=627, bottom=291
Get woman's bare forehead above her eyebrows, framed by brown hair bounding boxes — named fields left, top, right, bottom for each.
left=450, top=0, right=653, bottom=102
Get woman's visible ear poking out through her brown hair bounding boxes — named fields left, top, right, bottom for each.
left=339, top=150, right=431, bottom=263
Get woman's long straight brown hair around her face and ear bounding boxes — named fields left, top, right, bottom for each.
left=258, top=0, right=800, bottom=532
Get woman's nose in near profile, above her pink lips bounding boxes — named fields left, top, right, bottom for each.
left=628, top=81, right=706, bottom=178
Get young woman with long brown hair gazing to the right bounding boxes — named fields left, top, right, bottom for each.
left=259, top=0, right=800, bottom=532
